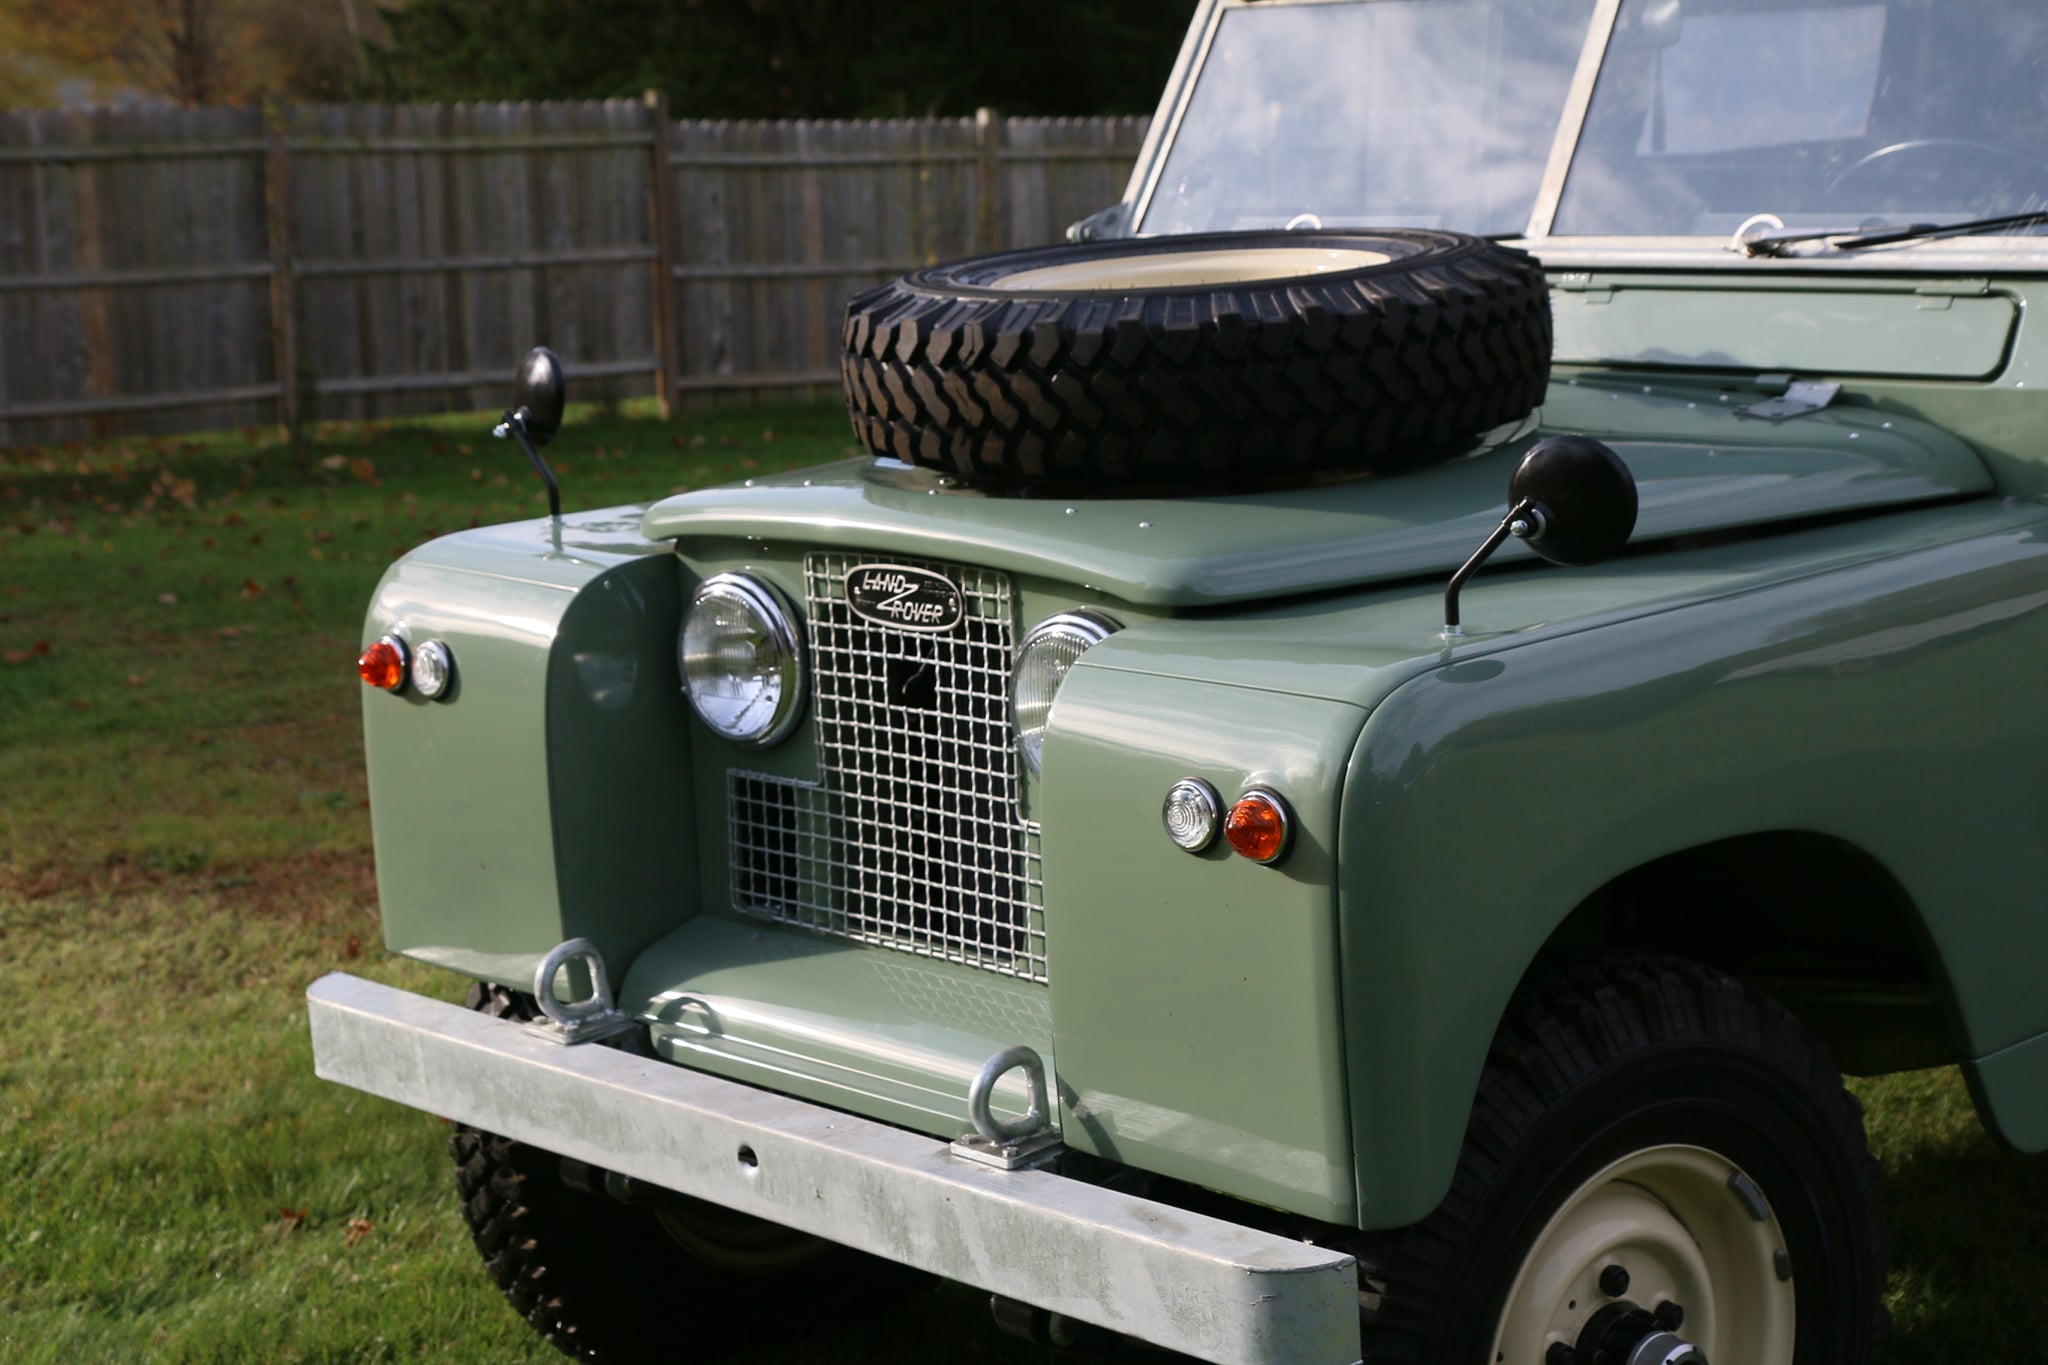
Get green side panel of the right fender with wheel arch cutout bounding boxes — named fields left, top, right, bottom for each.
left=1341, top=505, right=2048, bottom=1226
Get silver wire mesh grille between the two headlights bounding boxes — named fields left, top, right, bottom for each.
left=727, top=555, right=1044, bottom=980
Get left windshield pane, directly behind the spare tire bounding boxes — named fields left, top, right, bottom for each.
left=1139, top=0, right=1593, bottom=233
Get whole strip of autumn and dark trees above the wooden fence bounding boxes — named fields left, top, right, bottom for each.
left=0, top=0, right=1196, bottom=119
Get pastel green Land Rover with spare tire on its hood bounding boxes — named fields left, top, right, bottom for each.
left=309, top=0, right=2048, bottom=1365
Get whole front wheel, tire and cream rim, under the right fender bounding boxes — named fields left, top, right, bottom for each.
left=1360, top=954, right=1886, bottom=1365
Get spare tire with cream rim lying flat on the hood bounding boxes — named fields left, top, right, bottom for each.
left=842, top=229, right=1550, bottom=493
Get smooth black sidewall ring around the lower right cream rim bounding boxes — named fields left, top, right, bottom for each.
left=1434, top=1044, right=1878, bottom=1365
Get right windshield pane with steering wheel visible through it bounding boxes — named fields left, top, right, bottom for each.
left=1552, top=0, right=2048, bottom=237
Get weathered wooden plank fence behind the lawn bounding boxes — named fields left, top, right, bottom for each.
left=0, top=96, right=1145, bottom=446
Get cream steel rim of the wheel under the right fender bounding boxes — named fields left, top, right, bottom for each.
left=1487, top=1146, right=1794, bottom=1365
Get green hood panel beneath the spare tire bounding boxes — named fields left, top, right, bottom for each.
left=641, top=381, right=1993, bottom=608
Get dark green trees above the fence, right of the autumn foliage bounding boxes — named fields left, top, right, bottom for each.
left=367, top=0, right=1194, bottom=119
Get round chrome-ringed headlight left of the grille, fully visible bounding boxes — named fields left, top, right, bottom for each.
left=676, top=573, right=803, bottom=745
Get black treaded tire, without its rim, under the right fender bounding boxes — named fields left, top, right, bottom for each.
left=1354, top=954, right=1888, bottom=1365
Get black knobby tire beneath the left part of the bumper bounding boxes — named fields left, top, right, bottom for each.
left=449, top=984, right=930, bottom=1361
